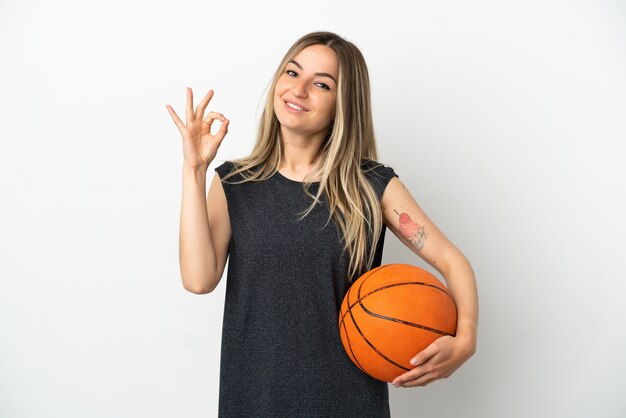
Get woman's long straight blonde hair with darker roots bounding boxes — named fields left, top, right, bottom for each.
left=224, top=32, right=382, bottom=280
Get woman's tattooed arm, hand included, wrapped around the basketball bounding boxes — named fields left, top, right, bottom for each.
left=381, top=177, right=478, bottom=387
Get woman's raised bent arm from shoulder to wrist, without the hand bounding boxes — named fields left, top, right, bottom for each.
left=179, top=168, right=231, bottom=294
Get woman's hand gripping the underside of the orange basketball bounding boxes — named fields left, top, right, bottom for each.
left=391, top=335, right=475, bottom=388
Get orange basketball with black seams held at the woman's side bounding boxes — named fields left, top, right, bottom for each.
left=339, top=264, right=456, bottom=382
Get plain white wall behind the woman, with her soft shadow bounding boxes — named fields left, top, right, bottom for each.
left=0, top=0, right=626, bottom=418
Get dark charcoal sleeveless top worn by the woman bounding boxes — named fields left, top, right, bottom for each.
left=215, top=161, right=397, bottom=418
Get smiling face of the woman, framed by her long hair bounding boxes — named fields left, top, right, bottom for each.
left=274, top=45, right=339, bottom=136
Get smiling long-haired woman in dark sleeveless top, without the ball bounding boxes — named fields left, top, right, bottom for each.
left=167, top=32, right=478, bottom=417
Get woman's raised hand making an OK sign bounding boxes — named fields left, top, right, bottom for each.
left=165, top=87, right=230, bottom=170
